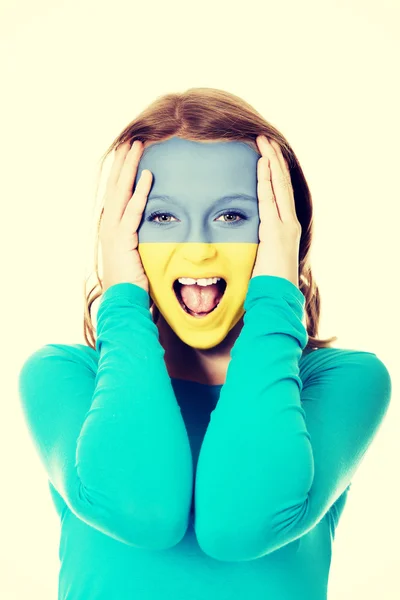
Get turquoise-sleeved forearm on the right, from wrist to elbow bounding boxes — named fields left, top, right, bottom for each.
left=195, top=277, right=314, bottom=560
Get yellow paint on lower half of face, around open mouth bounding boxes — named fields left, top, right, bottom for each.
left=138, top=243, right=257, bottom=350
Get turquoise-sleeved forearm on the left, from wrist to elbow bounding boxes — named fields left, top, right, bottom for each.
left=76, top=284, right=193, bottom=543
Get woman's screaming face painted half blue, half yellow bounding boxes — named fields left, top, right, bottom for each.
left=135, top=137, right=260, bottom=350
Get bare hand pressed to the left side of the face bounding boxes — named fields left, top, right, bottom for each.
left=99, top=140, right=153, bottom=293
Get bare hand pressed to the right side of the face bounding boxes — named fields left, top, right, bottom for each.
left=252, top=135, right=301, bottom=287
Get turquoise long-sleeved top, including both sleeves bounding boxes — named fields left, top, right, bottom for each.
left=19, top=275, right=391, bottom=600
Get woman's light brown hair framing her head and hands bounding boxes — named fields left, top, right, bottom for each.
left=83, top=88, right=338, bottom=349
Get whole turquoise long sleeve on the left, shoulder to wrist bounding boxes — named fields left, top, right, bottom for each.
left=19, top=283, right=193, bottom=549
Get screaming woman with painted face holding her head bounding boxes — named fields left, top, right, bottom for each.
left=20, top=88, right=391, bottom=600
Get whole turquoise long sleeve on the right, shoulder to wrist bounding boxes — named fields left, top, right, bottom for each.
left=194, top=276, right=391, bottom=561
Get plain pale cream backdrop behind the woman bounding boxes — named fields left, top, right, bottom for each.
left=0, top=0, right=400, bottom=600
